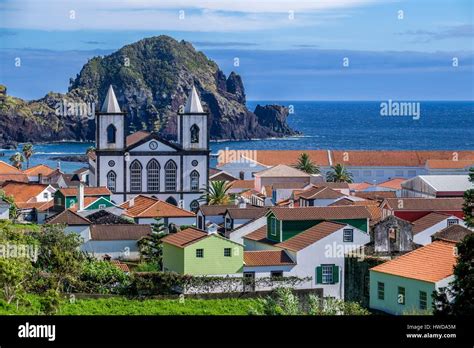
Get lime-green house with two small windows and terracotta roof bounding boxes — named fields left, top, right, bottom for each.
left=162, top=228, right=244, bottom=275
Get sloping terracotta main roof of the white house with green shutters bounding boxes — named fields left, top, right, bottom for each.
left=275, top=221, right=347, bottom=251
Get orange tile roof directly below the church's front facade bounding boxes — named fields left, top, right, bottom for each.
left=120, top=195, right=196, bottom=218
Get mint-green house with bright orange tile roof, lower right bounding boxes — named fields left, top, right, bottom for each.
left=369, top=241, right=456, bottom=315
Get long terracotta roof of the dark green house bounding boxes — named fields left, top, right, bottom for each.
left=270, top=206, right=370, bottom=220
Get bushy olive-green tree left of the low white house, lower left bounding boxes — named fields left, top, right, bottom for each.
left=33, top=225, right=84, bottom=291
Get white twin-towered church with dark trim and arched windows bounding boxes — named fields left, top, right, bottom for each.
left=89, top=86, right=210, bottom=210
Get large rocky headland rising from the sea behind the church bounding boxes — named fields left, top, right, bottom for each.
left=0, top=36, right=296, bottom=147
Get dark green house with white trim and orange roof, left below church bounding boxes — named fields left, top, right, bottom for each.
left=54, top=187, right=114, bottom=211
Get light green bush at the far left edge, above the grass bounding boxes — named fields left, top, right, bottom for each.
left=0, top=258, right=31, bottom=303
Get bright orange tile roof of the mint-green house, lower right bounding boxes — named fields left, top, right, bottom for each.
left=371, top=241, right=456, bottom=283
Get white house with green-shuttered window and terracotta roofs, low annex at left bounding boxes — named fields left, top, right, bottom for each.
left=243, top=221, right=370, bottom=299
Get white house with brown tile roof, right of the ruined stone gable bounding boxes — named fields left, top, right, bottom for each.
left=412, top=213, right=465, bottom=245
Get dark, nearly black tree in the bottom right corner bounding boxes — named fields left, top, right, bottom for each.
left=433, top=233, right=474, bottom=315
